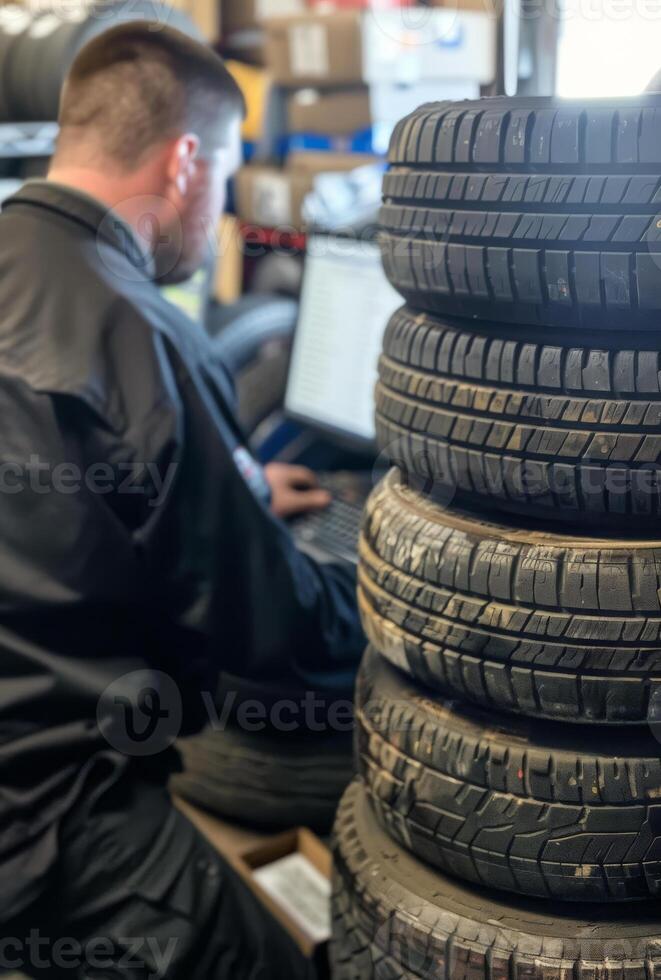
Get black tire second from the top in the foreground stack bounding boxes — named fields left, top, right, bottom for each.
left=376, top=307, right=661, bottom=532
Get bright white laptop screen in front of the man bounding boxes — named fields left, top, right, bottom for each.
left=285, top=235, right=402, bottom=444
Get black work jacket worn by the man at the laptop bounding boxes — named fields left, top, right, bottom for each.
left=0, top=182, right=363, bottom=919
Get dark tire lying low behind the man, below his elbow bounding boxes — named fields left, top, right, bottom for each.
left=171, top=727, right=354, bottom=835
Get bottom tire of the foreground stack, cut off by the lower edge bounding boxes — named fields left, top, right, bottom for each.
left=331, top=782, right=661, bottom=980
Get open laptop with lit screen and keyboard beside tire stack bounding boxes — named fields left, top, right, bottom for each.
left=285, top=235, right=402, bottom=564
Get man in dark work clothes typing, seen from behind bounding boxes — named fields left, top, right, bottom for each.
left=0, top=22, right=362, bottom=980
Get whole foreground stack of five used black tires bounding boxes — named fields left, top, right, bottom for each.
left=332, top=95, right=661, bottom=980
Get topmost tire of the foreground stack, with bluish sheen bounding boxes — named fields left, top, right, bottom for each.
left=381, top=94, right=661, bottom=332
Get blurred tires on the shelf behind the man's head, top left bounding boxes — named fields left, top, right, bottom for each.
left=0, top=0, right=201, bottom=122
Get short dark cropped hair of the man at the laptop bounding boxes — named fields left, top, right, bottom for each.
left=59, top=21, right=244, bottom=167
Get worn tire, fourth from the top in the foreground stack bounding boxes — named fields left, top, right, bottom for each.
left=357, top=649, right=661, bottom=902
